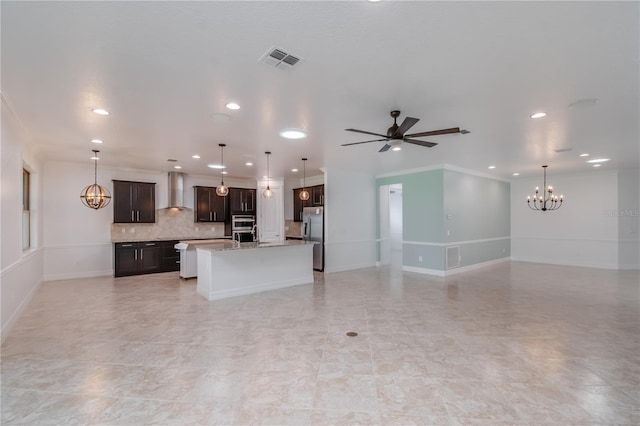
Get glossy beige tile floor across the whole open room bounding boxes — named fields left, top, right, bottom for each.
left=1, top=262, right=640, bottom=425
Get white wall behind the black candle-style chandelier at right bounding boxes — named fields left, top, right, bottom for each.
left=511, top=169, right=618, bottom=269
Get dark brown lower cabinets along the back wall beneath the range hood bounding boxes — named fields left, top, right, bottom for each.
left=114, top=241, right=175, bottom=277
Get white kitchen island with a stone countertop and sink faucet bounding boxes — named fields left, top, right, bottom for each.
left=196, top=241, right=315, bottom=300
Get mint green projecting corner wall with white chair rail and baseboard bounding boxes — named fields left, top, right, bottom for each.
left=376, top=166, right=510, bottom=276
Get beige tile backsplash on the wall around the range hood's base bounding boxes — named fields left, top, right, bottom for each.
left=111, top=209, right=224, bottom=243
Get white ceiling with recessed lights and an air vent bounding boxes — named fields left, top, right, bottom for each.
left=0, top=0, right=640, bottom=179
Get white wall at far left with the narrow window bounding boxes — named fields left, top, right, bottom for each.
left=0, top=95, right=44, bottom=340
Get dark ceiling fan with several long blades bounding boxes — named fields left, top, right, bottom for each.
left=342, top=111, right=469, bottom=152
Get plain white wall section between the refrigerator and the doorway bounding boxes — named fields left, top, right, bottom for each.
left=324, top=169, right=377, bottom=272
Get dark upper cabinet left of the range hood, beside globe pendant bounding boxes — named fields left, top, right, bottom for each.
left=113, top=180, right=156, bottom=223
